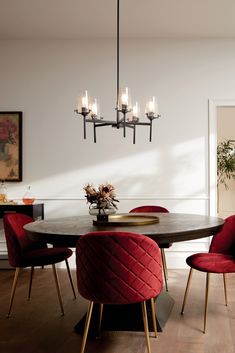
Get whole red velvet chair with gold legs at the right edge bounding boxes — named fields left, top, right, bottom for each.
left=181, top=216, right=235, bottom=333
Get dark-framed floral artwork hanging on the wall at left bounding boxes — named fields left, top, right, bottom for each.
left=0, top=112, right=23, bottom=181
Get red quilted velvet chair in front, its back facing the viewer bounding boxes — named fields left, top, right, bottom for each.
left=76, top=232, right=162, bottom=353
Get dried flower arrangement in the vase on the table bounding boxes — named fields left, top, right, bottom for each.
left=84, top=183, right=119, bottom=210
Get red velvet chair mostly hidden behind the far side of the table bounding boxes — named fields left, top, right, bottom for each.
left=130, top=206, right=172, bottom=291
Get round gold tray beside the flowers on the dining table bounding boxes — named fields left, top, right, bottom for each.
left=93, top=214, right=159, bottom=227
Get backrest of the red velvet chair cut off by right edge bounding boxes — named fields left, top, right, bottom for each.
left=209, top=215, right=235, bottom=256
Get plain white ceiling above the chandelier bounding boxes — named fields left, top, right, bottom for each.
left=0, top=0, right=235, bottom=39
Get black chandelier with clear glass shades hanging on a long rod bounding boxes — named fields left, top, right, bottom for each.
left=74, top=0, right=160, bottom=144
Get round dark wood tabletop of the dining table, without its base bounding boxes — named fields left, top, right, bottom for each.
left=24, top=213, right=224, bottom=246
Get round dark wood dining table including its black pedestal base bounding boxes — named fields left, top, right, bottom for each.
left=24, top=213, right=224, bottom=335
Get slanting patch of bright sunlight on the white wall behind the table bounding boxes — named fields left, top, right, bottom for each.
left=6, top=138, right=208, bottom=219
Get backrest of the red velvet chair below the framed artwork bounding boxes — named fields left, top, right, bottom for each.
left=3, top=213, right=47, bottom=267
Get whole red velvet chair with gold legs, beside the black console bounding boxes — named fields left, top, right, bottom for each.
left=3, top=213, right=76, bottom=317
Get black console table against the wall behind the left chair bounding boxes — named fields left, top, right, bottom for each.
left=0, top=203, right=44, bottom=268
